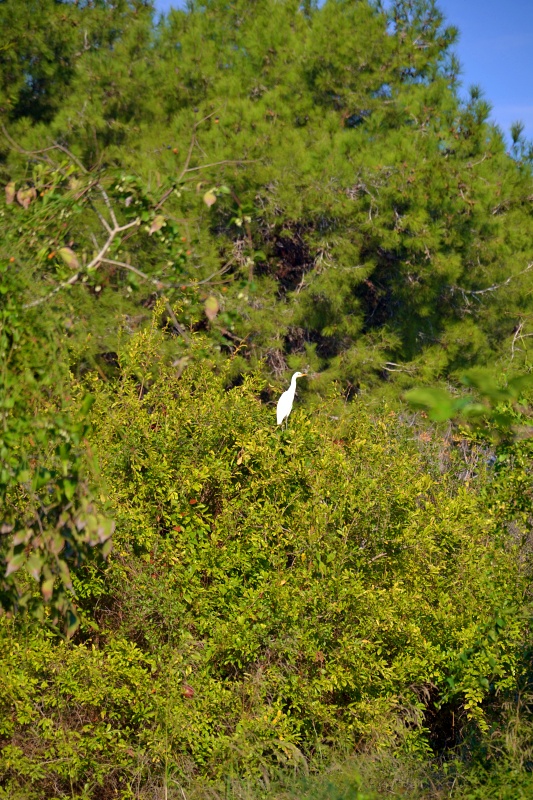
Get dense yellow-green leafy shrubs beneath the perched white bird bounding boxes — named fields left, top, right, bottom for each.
left=0, top=323, right=527, bottom=800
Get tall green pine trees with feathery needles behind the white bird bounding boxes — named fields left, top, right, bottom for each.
left=0, top=0, right=532, bottom=394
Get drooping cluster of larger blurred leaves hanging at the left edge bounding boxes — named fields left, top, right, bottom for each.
left=0, top=368, right=113, bottom=633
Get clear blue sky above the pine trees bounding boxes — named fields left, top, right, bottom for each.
left=155, top=0, right=533, bottom=140
